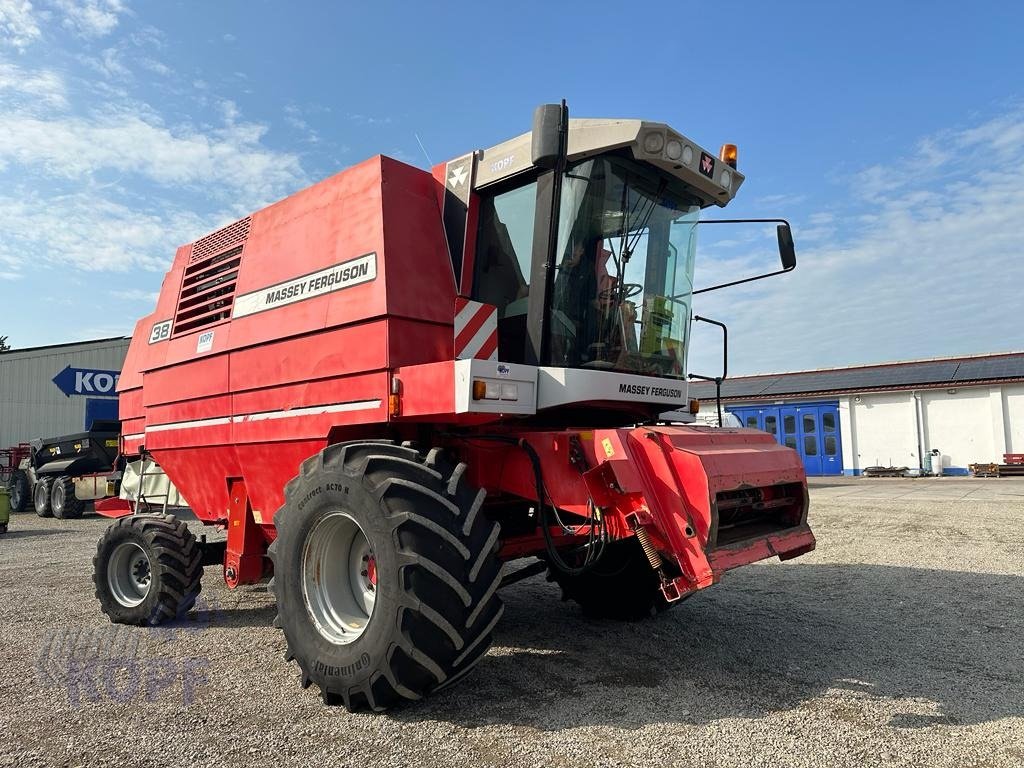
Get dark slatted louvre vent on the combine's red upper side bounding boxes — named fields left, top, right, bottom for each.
left=173, top=243, right=248, bottom=336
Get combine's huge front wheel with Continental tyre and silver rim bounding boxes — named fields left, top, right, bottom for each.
left=269, top=442, right=504, bottom=711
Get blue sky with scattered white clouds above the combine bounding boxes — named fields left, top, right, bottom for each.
left=0, top=0, right=1024, bottom=374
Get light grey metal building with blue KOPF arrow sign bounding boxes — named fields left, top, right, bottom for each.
left=0, top=337, right=129, bottom=449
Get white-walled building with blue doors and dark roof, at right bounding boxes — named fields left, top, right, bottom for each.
left=690, top=352, right=1024, bottom=475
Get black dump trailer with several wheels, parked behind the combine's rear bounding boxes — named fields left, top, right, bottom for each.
left=7, top=420, right=121, bottom=519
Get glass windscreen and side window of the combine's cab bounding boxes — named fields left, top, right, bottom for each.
left=471, top=154, right=700, bottom=378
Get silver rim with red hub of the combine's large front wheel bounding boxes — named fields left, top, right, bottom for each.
left=302, top=512, right=377, bottom=645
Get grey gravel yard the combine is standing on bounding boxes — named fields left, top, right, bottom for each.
left=0, top=479, right=1024, bottom=768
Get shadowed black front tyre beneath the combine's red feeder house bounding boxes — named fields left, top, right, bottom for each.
left=548, top=537, right=676, bottom=622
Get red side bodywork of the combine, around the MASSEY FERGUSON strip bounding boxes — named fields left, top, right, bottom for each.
left=121, top=157, right=456, bottom=522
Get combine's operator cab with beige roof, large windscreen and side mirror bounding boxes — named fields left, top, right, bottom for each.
left=435, top=109, right=796, bottom=423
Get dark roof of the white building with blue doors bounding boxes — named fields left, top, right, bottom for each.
left=690, top=352, right=1024, bottom=399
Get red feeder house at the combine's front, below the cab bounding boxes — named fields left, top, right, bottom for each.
left=470, top=426, right=814, bottom=594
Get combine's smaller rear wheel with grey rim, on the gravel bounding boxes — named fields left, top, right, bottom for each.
left=92, top=515, right=203, bottom=626
